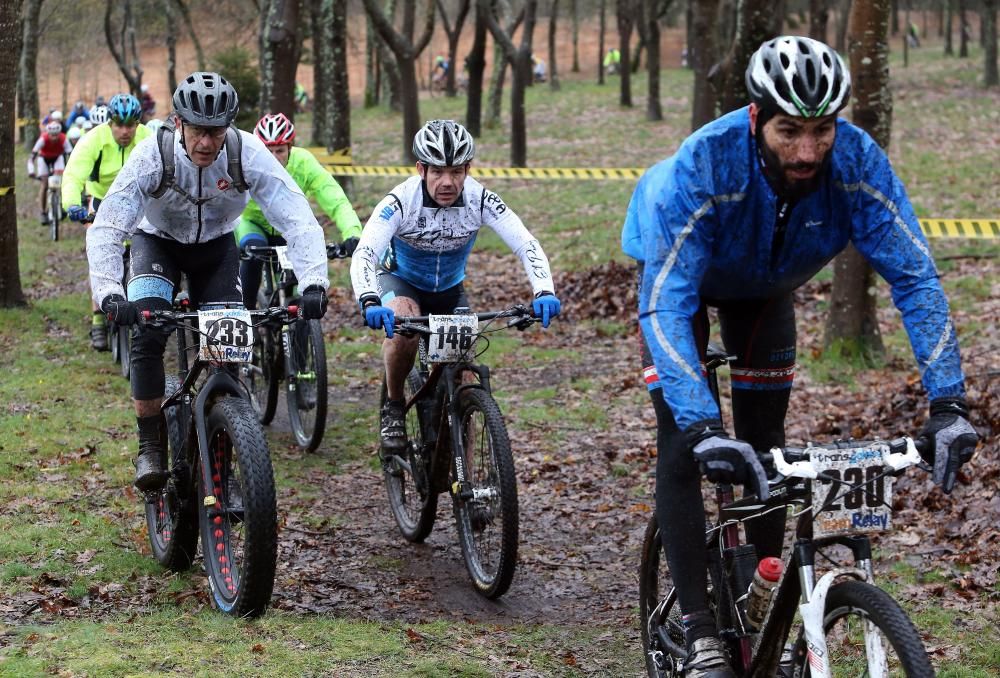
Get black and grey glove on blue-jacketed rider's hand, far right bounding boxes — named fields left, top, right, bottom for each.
left=920, top=398, right=979, bottom=494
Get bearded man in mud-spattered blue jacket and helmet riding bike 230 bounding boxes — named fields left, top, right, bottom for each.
left=622, top=37, right=977, bottom=678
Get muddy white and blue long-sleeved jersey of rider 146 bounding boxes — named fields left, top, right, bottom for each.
left=351, top=176, right=554, bottom=299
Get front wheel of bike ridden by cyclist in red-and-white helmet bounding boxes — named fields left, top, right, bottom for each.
left=285, top=320, right=327, bottom=452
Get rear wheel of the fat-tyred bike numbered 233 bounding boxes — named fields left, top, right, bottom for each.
left=146, top=376, right=198, bottom=572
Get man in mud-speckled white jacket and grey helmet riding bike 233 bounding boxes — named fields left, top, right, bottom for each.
left=87, top=72, right=329, bottom=492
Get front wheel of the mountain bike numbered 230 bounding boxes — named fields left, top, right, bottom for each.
left=794, top=580, right=934, bottom=678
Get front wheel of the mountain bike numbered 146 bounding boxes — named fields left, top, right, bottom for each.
left=452, top=388, right=518, bottom=598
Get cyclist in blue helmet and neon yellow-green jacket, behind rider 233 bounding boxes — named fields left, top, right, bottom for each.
left=62, top=94, right=150, bottom=351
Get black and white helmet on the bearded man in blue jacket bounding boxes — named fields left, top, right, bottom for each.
left=746, top=35, right=851, bottom=118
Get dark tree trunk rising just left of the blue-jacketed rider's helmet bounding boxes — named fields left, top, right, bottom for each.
left=717, top=0, right=781, bottom=113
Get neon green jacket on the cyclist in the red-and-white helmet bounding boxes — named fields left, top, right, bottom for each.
left=242, top=146, right=361, bottom=240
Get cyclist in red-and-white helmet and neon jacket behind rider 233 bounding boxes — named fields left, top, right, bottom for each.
left=234, top=113, right=361, bottom=308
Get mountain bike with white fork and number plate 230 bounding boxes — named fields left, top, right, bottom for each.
left=639, top=349, right=934, bottom=678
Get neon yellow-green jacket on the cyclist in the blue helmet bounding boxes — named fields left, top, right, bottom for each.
left=62, top=123, right=152, bottom=209
